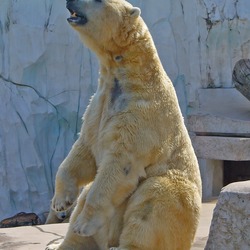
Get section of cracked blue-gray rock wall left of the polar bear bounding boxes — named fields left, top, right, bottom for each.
left=0, top=0, right=98, bottom=220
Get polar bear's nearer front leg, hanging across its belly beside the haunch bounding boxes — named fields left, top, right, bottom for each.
left=73, top=155, right=145, bottom=236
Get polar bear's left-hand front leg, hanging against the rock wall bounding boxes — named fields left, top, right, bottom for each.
left=52, top=137, right=96, bottom=211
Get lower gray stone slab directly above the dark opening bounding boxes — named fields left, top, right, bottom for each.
left=191, top=136, right=250, bottom=161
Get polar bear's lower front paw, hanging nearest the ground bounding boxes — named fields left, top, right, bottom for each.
left=72, top=211, right=104, bottom=236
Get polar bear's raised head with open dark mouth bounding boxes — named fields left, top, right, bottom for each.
left=67, top=0, right=143, bottom=53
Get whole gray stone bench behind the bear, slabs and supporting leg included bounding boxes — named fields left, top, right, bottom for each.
left=187, top=88, right=250, bottom=200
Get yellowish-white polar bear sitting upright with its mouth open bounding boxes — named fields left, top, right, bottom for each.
left=47, top=0, right=201, bottom=250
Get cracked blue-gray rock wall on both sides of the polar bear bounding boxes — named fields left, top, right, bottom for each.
left=0, top=0, right=250, bottom=220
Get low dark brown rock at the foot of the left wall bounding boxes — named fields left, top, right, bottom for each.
left=0, top=212, right=42, bottom=228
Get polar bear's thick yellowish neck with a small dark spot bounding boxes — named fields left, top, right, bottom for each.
left=97, top=32, right=164, bottom=85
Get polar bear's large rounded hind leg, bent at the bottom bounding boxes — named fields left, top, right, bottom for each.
left=117, top=173, right=201, bottom=250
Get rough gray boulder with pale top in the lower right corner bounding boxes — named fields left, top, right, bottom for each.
left=205, top=181, right=250, bottom=250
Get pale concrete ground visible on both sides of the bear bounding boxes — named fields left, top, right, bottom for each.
left=0, top=202, right=215, bottom=250
